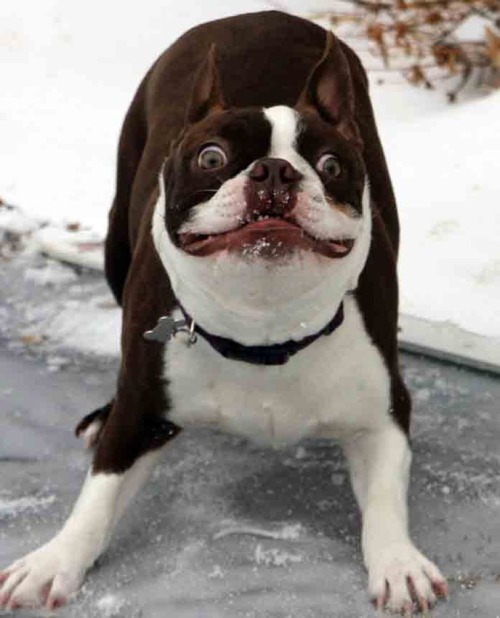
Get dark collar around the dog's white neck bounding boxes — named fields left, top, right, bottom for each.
left=180, top=303, right=344, bottom=365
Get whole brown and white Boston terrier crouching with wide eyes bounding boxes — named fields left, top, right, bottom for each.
left=1, top=12, right=447, bottom=611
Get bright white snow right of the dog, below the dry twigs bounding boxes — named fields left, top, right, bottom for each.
left=375, top=87, right=500, bottom=338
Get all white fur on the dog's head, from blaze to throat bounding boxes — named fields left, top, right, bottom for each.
left=152, top=106, right=371, bottom=345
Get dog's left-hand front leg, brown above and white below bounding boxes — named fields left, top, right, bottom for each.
left=0, top=224, right=179, bottom=608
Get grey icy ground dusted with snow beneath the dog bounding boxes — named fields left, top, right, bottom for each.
left=0, top=255, right=500, bottom=618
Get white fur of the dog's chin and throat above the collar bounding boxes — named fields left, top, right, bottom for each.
left=152, top=177, right=371, bottom=346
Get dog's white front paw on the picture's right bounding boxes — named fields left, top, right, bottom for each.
left=368, top=543, right=448, bottom=616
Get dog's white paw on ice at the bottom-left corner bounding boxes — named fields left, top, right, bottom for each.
left=0, top=537, right=85, bottom=610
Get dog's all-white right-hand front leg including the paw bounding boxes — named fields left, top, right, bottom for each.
left=344, top=421, right=447, bottom=612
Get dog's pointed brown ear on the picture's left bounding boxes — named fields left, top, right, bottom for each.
left=186, top=43, right=226, bottom=124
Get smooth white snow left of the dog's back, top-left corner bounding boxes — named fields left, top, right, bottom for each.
left=0, top=0, right=269, bottom=232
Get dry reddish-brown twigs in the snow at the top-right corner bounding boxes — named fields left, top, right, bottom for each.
left=316, top=0, right=500, bottom=101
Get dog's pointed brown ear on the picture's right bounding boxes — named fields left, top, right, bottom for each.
left=295, top=31, right=360, bottom=141
